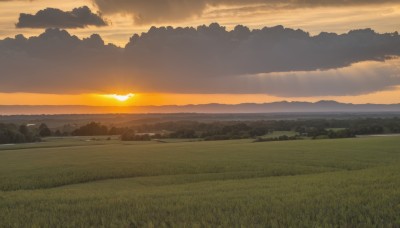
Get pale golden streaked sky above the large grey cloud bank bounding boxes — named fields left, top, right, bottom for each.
left=0, top=0, right=400, bottom=47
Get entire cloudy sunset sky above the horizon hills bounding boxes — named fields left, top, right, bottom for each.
left=0, top=0, right=400, bottom=106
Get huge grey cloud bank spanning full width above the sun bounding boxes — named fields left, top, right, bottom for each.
left=0, top=24, right=400, bottom=96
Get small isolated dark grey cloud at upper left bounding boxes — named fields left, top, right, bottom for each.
left=16, top=6, right=107, bottom=28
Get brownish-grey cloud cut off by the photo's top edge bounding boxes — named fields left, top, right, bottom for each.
left=93, top=0, right=400, bottom=24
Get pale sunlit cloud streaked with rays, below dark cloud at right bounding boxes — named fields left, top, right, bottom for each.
left=225, top=59, right=400, bottom=97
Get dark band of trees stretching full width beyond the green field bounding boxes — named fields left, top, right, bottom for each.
left=0, top=117, right=400, bottom=144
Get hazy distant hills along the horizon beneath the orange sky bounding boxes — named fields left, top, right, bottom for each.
left=0, top=101, right=400, bottom=115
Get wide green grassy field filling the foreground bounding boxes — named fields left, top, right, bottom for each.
left=0, top=137, right=400, bottom=227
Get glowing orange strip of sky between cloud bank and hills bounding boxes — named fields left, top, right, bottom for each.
left=0, top=87, right=400, bottom=106
